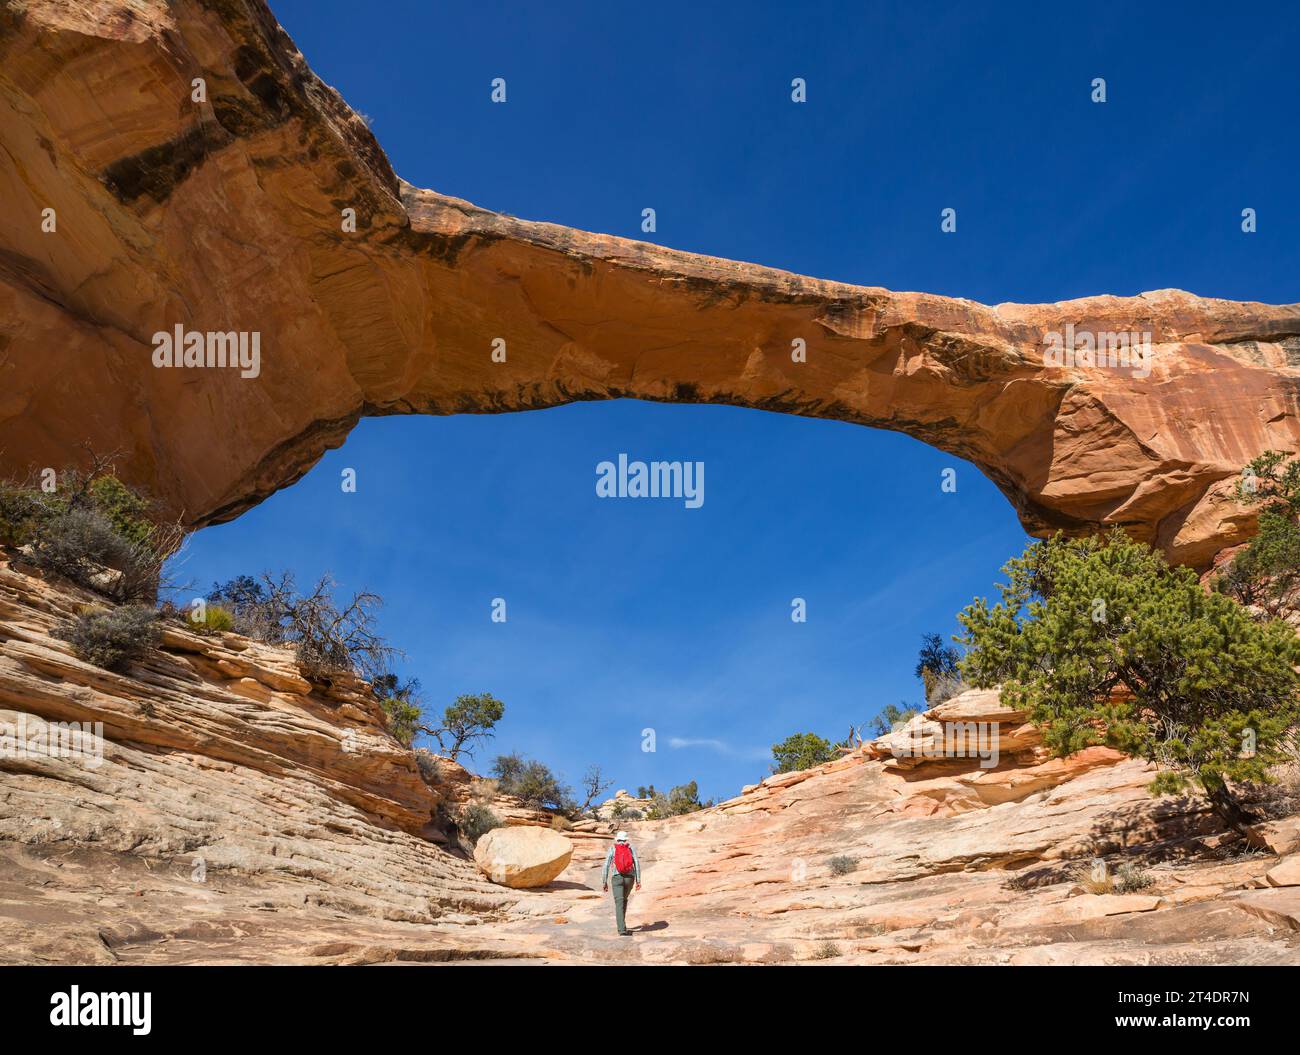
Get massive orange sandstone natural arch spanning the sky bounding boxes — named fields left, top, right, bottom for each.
left=0, top=0, right=1300, bottom=565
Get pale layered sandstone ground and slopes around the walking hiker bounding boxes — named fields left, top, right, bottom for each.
left=0, top=555, right=1300, bottom=964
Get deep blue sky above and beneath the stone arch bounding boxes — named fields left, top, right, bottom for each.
left=167, top=0, right=1300, bottom=796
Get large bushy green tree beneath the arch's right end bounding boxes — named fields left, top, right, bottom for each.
left=959, top=529, right=1300, bottom=830
